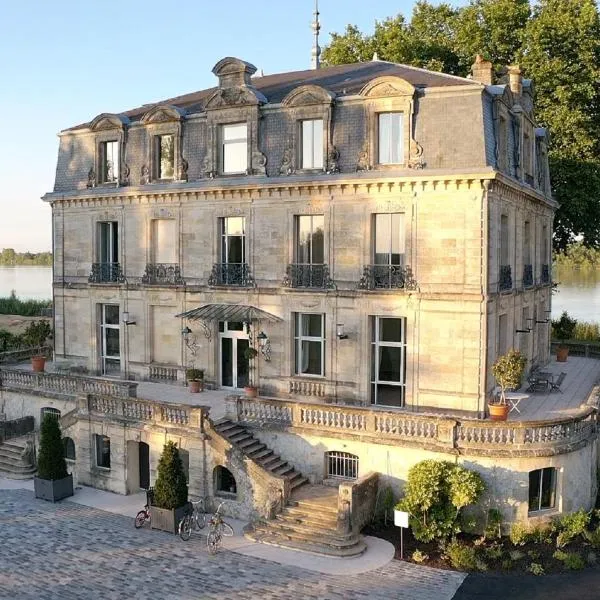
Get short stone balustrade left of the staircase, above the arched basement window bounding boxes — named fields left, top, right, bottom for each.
left=83, top=394, right=209, bottom=432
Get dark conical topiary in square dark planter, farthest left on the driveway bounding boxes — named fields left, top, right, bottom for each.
left=33, top=414, right=73, bottom=502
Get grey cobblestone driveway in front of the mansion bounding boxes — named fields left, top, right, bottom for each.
left=0, top=490, right=463, bottom=600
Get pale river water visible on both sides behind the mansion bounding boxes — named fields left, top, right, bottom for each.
left=0, top=266, right=600, bottom=322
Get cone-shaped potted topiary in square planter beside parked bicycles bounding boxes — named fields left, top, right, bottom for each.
left=150, top=442, right=188, bottom=533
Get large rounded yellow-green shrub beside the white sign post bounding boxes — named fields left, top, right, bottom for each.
left=397, top=460, right=485, bottom=542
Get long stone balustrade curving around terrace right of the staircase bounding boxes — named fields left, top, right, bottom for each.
left=226, top=396, right=598, bottom=457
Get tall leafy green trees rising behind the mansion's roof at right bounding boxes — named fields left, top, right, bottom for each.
left=323, top=0, right=600, bottom=251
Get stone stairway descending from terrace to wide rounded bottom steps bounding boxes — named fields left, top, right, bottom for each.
left=213, top=420, right=366, bottom=558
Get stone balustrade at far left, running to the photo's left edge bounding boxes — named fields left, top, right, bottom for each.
left=0, top=368, right=137, bottom=398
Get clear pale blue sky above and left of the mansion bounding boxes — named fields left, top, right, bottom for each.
left=0, top=0, right=462, bottom=252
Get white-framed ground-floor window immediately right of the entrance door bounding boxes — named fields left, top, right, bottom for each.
left=294, top=313, right=325, bottom=376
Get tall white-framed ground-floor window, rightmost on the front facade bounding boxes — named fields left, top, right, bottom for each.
left=371, top=317, right=406, bottom=406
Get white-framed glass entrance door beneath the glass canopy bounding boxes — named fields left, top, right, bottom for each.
left=219, top=321, right=250, bottom=389
